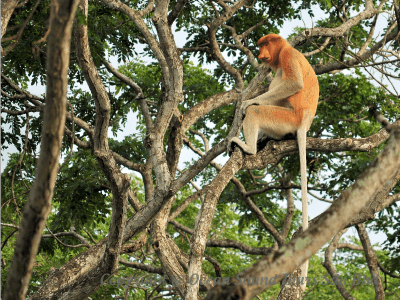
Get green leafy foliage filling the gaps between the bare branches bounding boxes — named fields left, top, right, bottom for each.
left=0, top=0, right=400, bottom=300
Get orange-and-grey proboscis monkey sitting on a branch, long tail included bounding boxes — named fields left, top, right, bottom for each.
left=228, top=34, right=319, bottom=290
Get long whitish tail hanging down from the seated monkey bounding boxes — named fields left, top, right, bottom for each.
left=297, top=124, right=308, bottom=291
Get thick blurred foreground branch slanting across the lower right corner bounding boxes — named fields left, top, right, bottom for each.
left=205, top=126, right=400, bottom=300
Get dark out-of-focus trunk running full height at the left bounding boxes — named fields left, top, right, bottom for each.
left=2, top=0, right=78, bottom=299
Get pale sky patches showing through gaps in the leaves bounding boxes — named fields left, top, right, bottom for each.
left=1, top=3, right=394, bottom=244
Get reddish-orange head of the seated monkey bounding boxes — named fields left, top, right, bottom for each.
left=258, top=33, right=287, bottom=68
